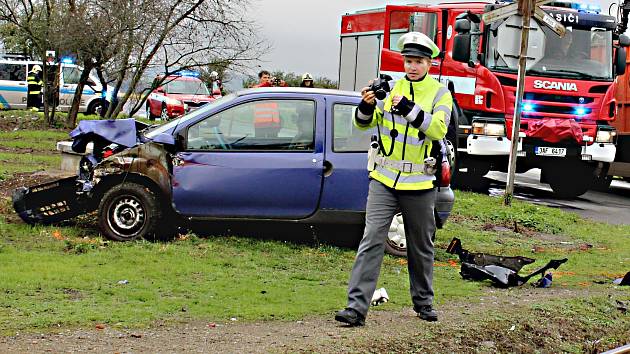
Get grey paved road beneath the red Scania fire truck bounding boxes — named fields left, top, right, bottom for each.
left=486, top=169, right=630, bottom=225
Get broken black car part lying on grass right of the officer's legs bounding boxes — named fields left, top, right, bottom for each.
left=446, top=238, right=568, bottom=288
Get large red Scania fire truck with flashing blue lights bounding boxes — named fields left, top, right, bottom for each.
left=339, top=2, right=629, bottom=198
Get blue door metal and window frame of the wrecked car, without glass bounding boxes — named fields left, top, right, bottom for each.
left=173, top=93, right=334, bottom=219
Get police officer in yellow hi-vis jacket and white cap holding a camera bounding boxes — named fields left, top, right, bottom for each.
left=335, top=32, right=453, bottom=326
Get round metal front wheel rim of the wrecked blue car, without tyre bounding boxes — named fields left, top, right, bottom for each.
left=107, top=196, right=146, bottom=237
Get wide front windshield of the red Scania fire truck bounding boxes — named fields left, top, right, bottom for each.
left=487, top=26, right=614, bottom=81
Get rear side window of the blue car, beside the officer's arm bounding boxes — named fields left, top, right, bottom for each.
left=333, top=104, right=376, bottom=152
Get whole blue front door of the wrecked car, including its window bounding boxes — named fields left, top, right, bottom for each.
left=173, top=96, right=325, bottom=219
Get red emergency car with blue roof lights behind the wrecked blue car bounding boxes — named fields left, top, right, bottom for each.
left=146, top=71, right=221, bottom=120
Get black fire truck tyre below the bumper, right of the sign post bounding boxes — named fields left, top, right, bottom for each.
left=543, top=163, right=595, bottom=199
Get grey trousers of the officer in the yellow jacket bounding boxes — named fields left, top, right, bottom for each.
left=348, top=180, right=436, bottom=316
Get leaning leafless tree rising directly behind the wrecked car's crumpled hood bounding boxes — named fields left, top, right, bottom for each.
left=111, top=0, right=268, bottom=116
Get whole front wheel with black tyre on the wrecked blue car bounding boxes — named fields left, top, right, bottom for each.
left=98, top=182, right=164, bottom=241
